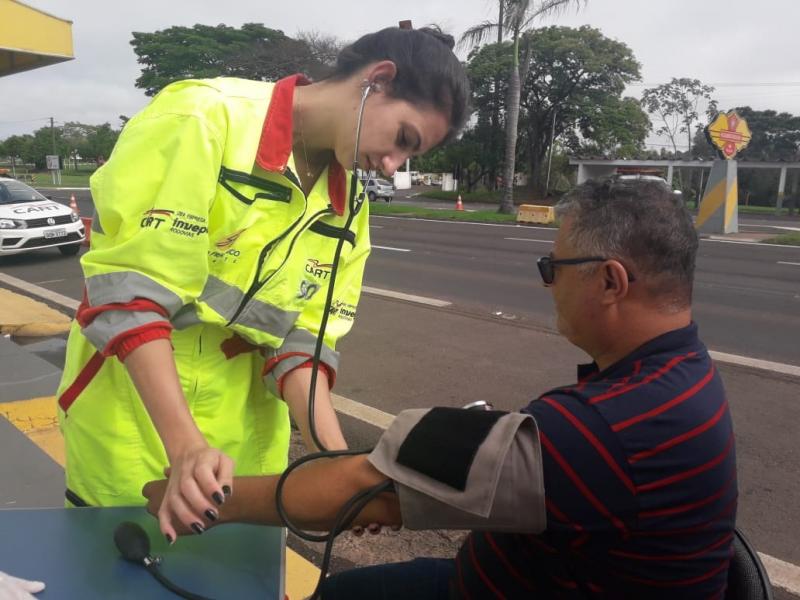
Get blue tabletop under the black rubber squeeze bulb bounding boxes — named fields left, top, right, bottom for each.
left=0, top=508, right=286, bottom=600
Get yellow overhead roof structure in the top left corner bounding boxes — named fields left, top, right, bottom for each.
left=0, top=0, right=75, bottom=76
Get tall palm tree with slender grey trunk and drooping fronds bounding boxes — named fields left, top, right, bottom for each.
left=461, top=0, right=586, bottom=214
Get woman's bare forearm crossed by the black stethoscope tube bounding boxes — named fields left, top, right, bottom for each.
left=283, top=369, right=347, bottom=452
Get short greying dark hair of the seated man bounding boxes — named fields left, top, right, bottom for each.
left=556, top=179, right=698, bottom=310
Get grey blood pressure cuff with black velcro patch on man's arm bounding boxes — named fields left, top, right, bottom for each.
left=368, top=407, right=547, bottom=533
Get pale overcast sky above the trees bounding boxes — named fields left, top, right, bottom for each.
left=0, top=0, right=800, bottom=149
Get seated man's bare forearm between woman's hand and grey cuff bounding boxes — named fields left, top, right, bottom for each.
left=220, top=455, right=402, bottom=531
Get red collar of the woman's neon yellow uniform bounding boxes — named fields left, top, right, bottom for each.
left=256, top=74, right=347, bottom=216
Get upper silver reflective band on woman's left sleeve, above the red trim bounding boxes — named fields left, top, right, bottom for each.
left=86, top=271, right=183, bottom=316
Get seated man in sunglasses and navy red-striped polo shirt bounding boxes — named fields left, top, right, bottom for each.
left=144, top=181, right=737, bottom=600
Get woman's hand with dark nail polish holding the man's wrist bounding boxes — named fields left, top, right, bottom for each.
left=154, top=445, right=233, bottom=544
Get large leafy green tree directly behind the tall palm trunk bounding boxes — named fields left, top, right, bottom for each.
left=437, top=26, right=650, bottom=192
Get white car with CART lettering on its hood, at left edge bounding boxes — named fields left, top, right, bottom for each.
left=0, top=177, right=85, bottom=256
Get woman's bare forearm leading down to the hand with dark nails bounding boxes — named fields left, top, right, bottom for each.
left=125, top=339, right=205, bottom=461
